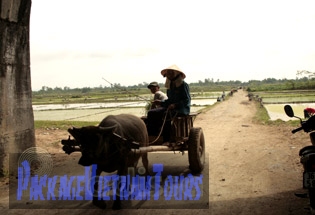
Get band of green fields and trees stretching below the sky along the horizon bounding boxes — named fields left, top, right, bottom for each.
left=32, top=77, right=315, bottom=104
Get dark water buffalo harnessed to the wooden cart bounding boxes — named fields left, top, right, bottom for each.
left=68, top=114, right=149, bottom=209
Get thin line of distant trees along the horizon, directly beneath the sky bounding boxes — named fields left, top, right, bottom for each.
left=33, top=70, right=315, bottom=95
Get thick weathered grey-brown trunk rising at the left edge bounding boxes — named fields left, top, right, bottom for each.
left=0, top=0, right=35, bottom=176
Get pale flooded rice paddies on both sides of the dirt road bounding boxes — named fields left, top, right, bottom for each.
left=33, top=99, right=315, bottom=121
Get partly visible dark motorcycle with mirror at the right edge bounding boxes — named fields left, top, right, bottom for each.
left=284, top=105, right=315, bottom=211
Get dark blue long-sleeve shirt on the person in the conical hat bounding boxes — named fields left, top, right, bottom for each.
left=161, top=81, right=191, bottom=115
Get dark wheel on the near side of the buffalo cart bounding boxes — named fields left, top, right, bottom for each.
left=188, top=128, right=205, bottom=173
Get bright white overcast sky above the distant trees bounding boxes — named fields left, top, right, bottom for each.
left=30, top=0, right=315, bottom=90
